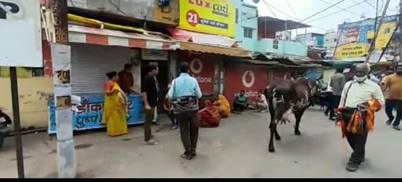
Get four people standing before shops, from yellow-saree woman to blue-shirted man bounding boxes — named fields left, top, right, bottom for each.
left=102, top=63, right=202, bottom=160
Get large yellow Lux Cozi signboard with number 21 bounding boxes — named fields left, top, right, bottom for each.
left=179, top=0, right=236, bottom=37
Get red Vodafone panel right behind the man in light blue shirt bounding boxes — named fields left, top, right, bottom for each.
left=179, top=52, right=219, bottom=94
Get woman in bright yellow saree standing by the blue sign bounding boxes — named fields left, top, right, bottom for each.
left=102, top=72, right=128, bottom=137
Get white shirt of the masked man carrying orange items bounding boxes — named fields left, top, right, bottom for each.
left=339, top=79, right=385, bottom=108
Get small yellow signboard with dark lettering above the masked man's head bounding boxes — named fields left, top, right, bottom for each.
left=336, top=43, right=368, bottom=59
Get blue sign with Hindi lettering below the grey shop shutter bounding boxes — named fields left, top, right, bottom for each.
left=48, top=96, right=145, bottom=134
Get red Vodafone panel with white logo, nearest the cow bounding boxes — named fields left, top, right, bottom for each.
left=225, top=64, right=269, bottom=103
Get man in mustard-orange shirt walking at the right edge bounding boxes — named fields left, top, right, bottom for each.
left=382, top=63, right=402, bottom=131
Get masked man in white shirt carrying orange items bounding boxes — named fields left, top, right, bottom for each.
left=337, top=64, right=384, bottom=172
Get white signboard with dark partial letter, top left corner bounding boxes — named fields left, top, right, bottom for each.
left=0, top=0, right=43, bottom=67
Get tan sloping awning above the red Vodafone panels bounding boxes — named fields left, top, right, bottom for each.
left=178, top=42, right=251, bottom=57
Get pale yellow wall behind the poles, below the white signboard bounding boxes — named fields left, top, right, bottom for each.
left=0, top=77, right=53, bottom=129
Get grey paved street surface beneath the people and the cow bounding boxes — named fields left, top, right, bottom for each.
left=0, top=109, right=402, bottom=178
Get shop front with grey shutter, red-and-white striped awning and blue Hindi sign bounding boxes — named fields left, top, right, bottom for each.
left=48, top=25, right=175, bottom=134
